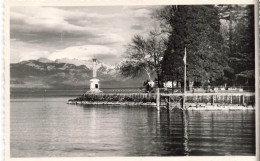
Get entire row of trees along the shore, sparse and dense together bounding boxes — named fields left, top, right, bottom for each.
left=120, top=5, right=255, bottom=87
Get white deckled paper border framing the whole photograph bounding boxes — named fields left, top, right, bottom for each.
left=3, top=0, right=259, bottom=161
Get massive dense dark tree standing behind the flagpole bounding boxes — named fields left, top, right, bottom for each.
left=157, top=5, right=226, bottom=86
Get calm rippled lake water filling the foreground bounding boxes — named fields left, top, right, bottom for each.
left=11, top=97, right=255, bottom=157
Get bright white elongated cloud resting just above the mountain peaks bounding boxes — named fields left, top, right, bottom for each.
left=48, top=45, right=117, bottom=61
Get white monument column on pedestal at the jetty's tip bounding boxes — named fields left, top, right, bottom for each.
left=88, top=58, right=102, bottom=93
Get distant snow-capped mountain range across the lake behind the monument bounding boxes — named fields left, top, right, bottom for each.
left=10, top=58, right=147, bottom=89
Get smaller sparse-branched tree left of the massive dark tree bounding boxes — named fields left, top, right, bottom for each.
left=120, top=29, right=165, bottom=87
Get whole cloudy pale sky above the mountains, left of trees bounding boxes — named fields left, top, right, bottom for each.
left=10, top=6, right=161, bottom=65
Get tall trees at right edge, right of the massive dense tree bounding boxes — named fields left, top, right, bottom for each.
left=218, top=5, right=255, bottom=85
